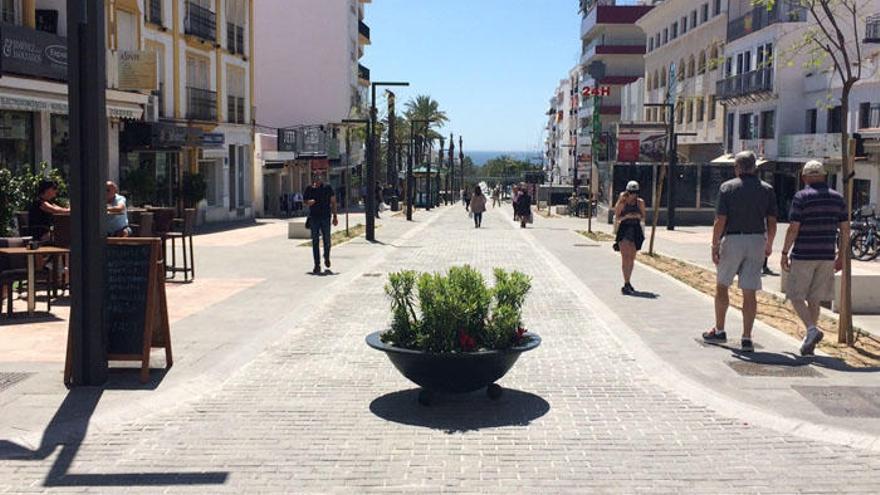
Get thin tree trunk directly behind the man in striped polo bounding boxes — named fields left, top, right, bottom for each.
left=837, top=92, right=854, bottom=346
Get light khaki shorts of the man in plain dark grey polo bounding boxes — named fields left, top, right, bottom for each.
left=717, top=234, right=767, bottom=290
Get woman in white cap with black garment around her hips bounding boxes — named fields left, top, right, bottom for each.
left=614, top=180, right=645, bottom=296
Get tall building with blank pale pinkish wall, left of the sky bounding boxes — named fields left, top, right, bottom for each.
left=256, top=0, right=370, bottom=217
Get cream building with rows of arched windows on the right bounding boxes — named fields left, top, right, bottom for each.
left=634, top=0, right=727, bottom=163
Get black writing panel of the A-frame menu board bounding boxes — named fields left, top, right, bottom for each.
left=104, top=244, right=155, bottom=356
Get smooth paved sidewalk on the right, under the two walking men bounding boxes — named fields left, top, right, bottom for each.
left=533, top=212, right=880, bottom=441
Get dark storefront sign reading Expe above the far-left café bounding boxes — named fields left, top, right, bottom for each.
left=0, top=24, right=67, bottom=81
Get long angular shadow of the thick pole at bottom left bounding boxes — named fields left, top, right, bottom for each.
left=0, top=370, right=229, bottom=487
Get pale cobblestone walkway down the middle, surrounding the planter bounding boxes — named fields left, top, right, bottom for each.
left=0, top=208, right=880, bottom=494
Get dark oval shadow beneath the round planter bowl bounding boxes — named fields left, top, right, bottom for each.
left=370, top=388, right=550, bottom=434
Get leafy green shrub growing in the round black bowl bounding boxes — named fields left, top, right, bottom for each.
left=382, top=266, right=531, bottom=353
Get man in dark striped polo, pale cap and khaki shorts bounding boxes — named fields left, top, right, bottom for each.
left=782, top=160, right=849, bottom=356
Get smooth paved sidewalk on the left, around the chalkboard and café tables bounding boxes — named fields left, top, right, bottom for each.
left=0, top=211, right=431, bottom=450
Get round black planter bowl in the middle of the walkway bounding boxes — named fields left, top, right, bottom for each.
left=367, top=332, right=541, bottom=403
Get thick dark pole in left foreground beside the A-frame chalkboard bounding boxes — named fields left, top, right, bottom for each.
left=66, top=0, right=109, bottom=386
